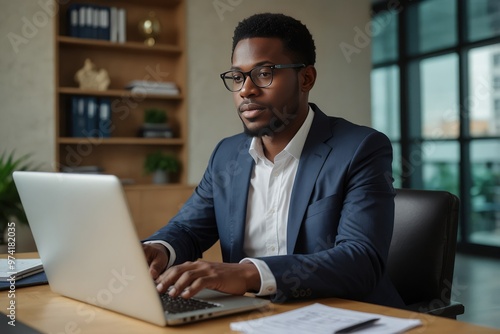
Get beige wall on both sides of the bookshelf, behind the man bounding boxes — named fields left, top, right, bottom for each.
left=0, top=0, right=371, bottom=183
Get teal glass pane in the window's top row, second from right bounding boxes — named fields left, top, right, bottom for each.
left=407, top=0, right=457, bottom=54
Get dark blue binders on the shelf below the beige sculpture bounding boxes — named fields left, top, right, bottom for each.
left=69, top=96, right=113, bottom=138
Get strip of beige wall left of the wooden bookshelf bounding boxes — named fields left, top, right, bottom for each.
left=0, top=0, right=55, bottom=170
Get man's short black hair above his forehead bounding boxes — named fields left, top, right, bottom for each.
left=231, top=13, right=316, bottom=65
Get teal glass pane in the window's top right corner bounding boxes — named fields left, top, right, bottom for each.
left=467, top=0, right=500, bottom=41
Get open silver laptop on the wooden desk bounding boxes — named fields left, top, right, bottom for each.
left=14, top=172, right=269, bottom=326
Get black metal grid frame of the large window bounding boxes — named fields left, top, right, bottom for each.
left=372, top=0, right=500, bottom=257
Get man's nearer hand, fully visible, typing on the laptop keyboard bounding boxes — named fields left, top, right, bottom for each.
left=155, top=261, right=261, bottom=298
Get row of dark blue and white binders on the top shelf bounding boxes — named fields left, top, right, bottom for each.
left=67, top=4, right=127, bottom=43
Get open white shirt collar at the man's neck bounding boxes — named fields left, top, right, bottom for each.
left=248, top=107, right=314, bottom=163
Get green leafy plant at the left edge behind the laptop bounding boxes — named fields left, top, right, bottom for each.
left=0, top=152, right=36, bottom=244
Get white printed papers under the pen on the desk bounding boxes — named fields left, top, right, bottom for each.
left=230, top=303, right=422, bottom=334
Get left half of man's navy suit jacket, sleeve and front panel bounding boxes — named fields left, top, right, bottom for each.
left=144, top=135, right=248, bottom=264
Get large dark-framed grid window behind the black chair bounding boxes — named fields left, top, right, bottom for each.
left=371, top=0, right=500, bottom=254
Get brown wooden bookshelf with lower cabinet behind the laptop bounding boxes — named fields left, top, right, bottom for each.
left=55, top=0, right=193, bottom=238
